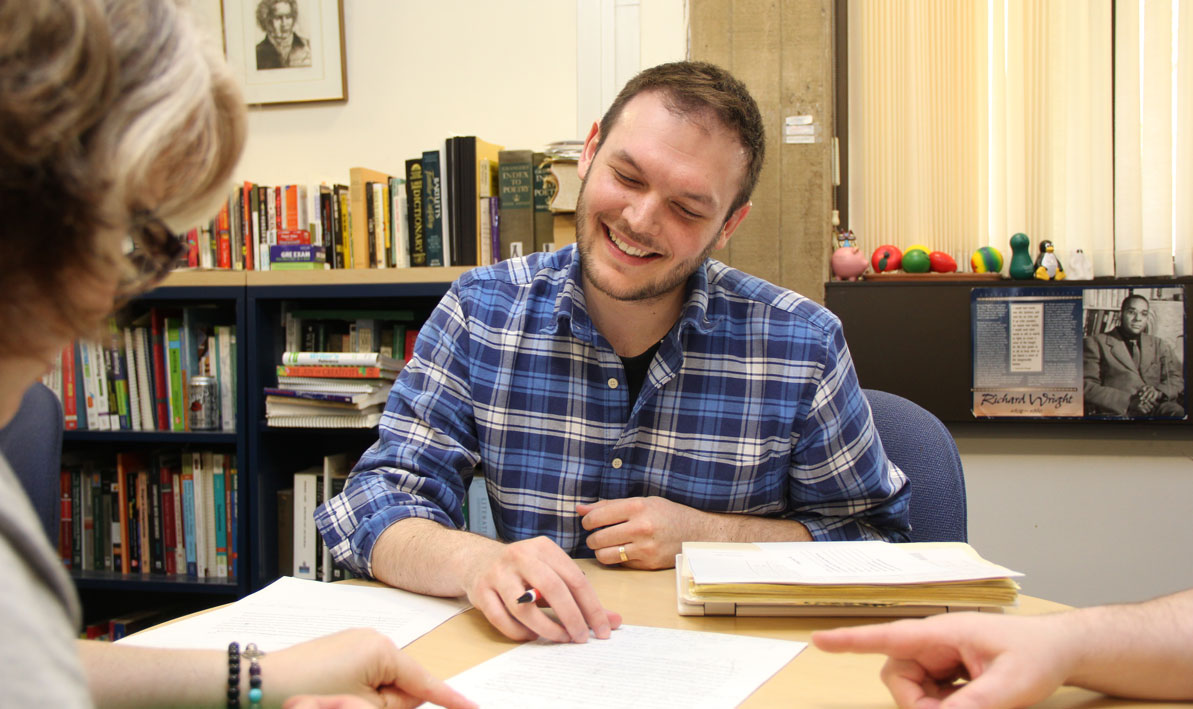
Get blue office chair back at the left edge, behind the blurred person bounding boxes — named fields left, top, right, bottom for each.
left=0, top=382, right=62, bottom=548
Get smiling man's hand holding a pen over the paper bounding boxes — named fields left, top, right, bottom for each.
left=464, top=537, right=622, bottom=642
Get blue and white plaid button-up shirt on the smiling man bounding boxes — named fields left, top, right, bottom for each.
left=315, top=247, right=909, bottom=575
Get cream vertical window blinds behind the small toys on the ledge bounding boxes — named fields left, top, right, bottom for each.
left=847, top=0, right=1193, bottom=276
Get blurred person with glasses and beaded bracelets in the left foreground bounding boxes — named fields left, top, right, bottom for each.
left=0, top=0, right=472, bottom=708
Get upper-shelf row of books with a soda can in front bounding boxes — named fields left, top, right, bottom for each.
left=42, top=307, right=236, bottom=431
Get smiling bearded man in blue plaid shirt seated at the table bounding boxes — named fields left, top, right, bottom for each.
left=316, top=62, right=909, bottom=642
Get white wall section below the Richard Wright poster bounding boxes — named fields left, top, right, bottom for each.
left=953, top=425, right=1193, bottom=605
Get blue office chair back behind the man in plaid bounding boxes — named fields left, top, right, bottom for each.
left=863, top=389, right=969, bottom=542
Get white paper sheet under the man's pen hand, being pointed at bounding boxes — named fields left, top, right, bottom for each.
left=447, top=625, right=808, bottom=709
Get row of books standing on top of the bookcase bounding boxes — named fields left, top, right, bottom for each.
left=174, top=136, right=580, bottom=271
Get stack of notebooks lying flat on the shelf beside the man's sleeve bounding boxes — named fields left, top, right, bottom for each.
left=265, top=352, right=403, bottom=429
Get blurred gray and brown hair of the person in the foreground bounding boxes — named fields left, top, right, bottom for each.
left=0, top=0, right=246, bottom=351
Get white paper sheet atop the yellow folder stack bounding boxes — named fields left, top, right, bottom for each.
left=684, top=542, right=1022, bottom=585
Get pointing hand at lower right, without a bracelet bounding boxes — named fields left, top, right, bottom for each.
left=812, top=614, right=1080, bottom=709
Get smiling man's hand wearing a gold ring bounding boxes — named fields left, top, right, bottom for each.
left=576, top=498, right=711, bottom=568
